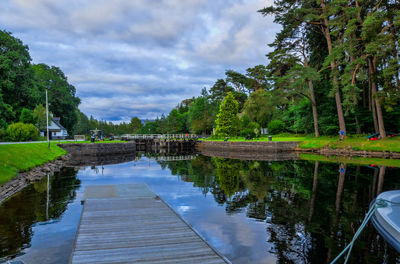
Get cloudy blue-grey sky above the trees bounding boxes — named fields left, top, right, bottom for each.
left=0, top=0, right=279, bottom=122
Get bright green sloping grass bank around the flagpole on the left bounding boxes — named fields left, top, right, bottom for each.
left=0, top=142, right=67, bottom=185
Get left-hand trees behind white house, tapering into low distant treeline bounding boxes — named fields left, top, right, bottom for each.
left=0, top=30, right=143, bottom=141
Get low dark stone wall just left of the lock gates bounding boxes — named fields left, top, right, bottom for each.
left=58, top=141, right=136, bottom=156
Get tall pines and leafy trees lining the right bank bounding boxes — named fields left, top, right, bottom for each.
left=142, top=0, right=400, bottom=138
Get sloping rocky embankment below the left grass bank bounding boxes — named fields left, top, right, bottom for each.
left=0, top=155, right=70, bottom=203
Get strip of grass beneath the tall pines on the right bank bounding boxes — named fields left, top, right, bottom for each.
left=203, top=134, right=400, bottom=152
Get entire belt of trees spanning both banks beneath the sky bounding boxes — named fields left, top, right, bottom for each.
left=0, top=0, right=400, bottom=138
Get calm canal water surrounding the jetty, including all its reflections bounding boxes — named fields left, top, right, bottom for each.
left=0, top=154, right=400, bottom=263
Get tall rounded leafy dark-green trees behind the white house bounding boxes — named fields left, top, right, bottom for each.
left=0, top=30, right=80, bottom=139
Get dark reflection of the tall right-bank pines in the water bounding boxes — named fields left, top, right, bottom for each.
left=160, top=156, right=400, bottom=263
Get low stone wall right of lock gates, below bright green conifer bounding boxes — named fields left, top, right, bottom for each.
left=196, top=141, right=300, bottom=153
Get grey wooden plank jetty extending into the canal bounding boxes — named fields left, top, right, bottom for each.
left=70, top=184, right=230, bottom=264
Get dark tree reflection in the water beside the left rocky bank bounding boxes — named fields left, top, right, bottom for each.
left=0, top=168, right=80, bottom=262
